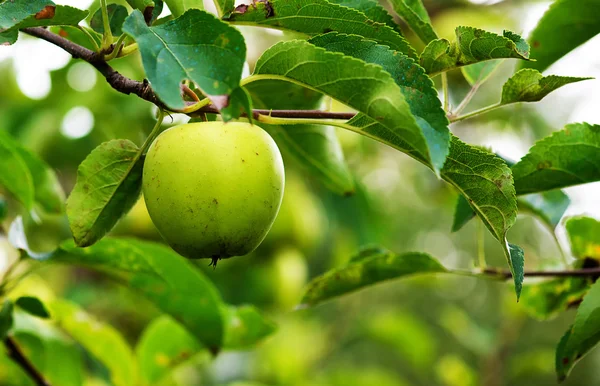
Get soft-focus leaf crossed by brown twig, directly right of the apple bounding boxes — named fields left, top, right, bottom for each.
left=246, top=80, right=354, bottom=195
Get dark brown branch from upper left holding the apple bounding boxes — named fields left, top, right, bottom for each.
left=22, top=27, right=354, bottom=120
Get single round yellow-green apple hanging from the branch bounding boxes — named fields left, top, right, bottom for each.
left=142, top=122, right=285, bottom=264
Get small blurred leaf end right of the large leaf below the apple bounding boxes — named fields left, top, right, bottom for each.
left=224, top=305, right=277, bottom=350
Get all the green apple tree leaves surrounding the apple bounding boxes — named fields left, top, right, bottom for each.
left=0, top=0, right=600, bottom=385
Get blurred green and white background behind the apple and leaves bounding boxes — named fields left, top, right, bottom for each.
left=0, top=0, right=600, bottom=386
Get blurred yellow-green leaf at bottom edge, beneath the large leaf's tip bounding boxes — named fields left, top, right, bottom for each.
left=135, top=315, right=208, bottom=385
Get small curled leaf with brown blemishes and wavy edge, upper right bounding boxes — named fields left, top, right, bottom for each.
left=420, top=27, right=529, bottom=76
